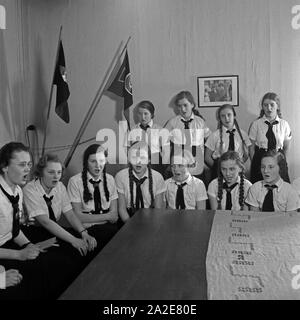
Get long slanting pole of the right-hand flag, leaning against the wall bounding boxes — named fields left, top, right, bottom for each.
left=64, top=36, right=131, bottom=168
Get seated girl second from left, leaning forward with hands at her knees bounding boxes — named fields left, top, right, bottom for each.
left=23, top=154, right=97, bottom=298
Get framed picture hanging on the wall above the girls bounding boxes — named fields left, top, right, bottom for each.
left=197, top=75, right=239, bottom=108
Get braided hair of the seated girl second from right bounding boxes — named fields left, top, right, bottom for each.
left=217, top=151, right=245, bottom=210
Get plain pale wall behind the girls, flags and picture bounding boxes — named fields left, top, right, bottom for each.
left=0, top=0, right=300, bottom=180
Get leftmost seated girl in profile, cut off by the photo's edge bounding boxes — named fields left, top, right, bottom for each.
left=0, top=142, right=64, bottom=300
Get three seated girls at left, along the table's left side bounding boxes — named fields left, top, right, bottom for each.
left=0, top=142, right=118, bottom=300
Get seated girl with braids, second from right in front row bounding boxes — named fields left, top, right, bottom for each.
left=207, top=151, right=251, bottom=211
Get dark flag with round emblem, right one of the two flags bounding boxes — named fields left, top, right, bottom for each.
left=107, top=50, right=133, bottom=123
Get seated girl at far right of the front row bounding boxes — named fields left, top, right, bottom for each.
left=246, top=150, right=300, bottom=212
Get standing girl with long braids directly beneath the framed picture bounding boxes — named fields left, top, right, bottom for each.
left=205, top=104, right=251, bottom=180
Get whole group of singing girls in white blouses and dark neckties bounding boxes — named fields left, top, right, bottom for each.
left=0, top=91, right=300, bottom=299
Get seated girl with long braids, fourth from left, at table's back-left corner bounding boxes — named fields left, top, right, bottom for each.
left=115, top=141, right=166, bottom=223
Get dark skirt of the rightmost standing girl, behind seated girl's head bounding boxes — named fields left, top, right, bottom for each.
left=250, top=146, right=290, bottom=183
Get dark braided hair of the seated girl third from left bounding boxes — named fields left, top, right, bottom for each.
left=81, top=143, right=109, bottom=203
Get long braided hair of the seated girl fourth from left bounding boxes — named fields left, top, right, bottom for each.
left=128, top=141, right=154, bottom=210
